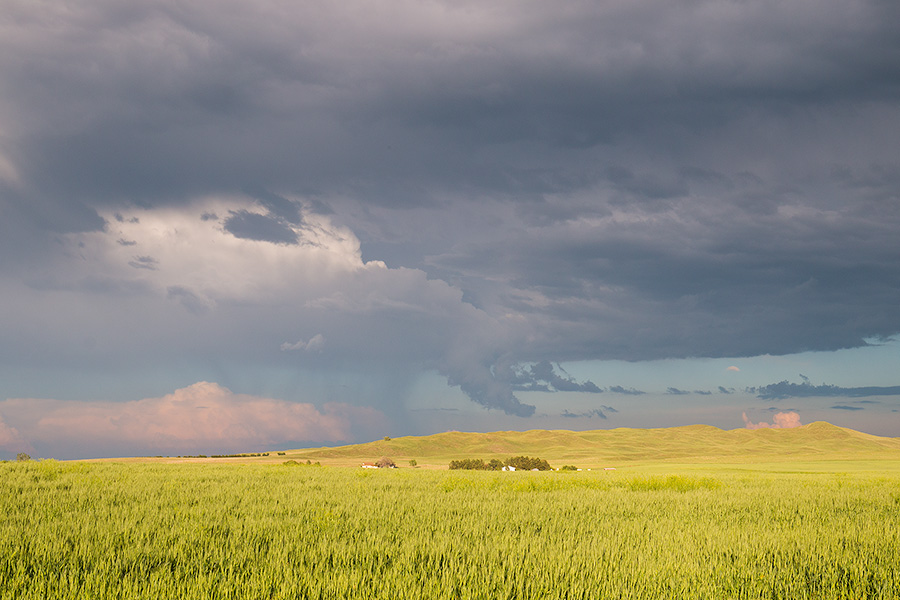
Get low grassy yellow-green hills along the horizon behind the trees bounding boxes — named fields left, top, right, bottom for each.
left=291, top=421, right=900, bottom=466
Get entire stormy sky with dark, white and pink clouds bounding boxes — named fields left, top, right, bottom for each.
left=0, top=0, right=900, bottom=459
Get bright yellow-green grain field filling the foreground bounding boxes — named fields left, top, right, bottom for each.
left=0, top=461, right=900, bottom=600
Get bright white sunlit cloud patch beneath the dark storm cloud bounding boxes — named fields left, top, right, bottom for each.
left=69, top=198, right=366, bottom=303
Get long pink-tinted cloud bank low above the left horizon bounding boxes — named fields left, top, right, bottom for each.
left=0, top=381, right=384, bottom=454
